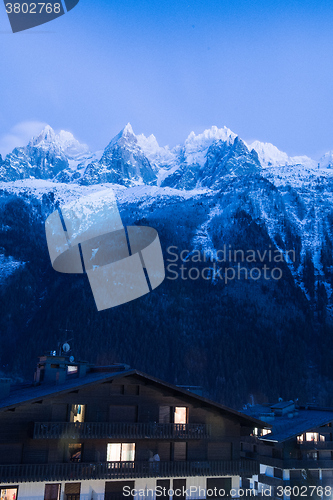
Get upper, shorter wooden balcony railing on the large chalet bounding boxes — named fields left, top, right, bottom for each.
left=33, top=422, right=210, bottom=440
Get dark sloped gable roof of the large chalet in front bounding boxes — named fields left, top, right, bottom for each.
left=0, top=367, right=269, bottom=428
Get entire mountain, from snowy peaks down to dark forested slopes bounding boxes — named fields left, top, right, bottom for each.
left=0, top=125, right=333, bottom=408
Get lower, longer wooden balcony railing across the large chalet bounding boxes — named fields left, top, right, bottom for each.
left=0, top=460, right=259, bottom=483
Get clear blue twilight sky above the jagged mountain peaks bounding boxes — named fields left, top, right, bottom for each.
left=0, top=0, right=333, bottom=158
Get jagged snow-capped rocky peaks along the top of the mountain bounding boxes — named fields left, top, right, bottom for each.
left=0, top=123, right=333, bottom=189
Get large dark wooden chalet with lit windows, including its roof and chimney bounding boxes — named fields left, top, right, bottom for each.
left=0, top=355, right=260, bottom=500
